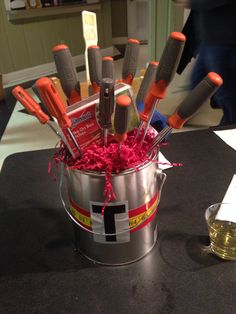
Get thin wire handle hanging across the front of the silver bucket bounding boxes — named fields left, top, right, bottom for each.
left=59, top=164, right=167, bottom=236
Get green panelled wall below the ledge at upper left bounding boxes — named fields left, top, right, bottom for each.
left=0, top=0, right=112, bottom=73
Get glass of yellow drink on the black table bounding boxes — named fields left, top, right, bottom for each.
left=205, top=203, right=236, bottom=260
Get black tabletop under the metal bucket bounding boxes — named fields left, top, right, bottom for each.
left=0, top=130, right=236, bottom=314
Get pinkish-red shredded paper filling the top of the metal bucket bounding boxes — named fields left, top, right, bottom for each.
left=53, top=130, right=180, bottom=210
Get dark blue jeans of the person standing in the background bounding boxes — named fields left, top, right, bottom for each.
left=191, top=45, right=236, bottom=125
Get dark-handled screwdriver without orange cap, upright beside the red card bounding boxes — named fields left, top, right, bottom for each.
left=99, top=78, right=115, bottom=147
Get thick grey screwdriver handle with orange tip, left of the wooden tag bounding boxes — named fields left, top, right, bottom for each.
left=52, top=44, right=81, bottom=104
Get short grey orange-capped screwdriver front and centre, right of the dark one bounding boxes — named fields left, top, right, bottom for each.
left=114, top=95, right=131, bottom=158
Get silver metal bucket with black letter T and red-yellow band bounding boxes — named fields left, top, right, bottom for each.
left=61, top=155, right=166, bottom=265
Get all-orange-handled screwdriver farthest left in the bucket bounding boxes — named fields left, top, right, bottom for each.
left=12, top=86, right=61, bottom=137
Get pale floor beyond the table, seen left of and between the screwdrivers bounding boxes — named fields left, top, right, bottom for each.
left=0, top=45, right=221, bottom=168
